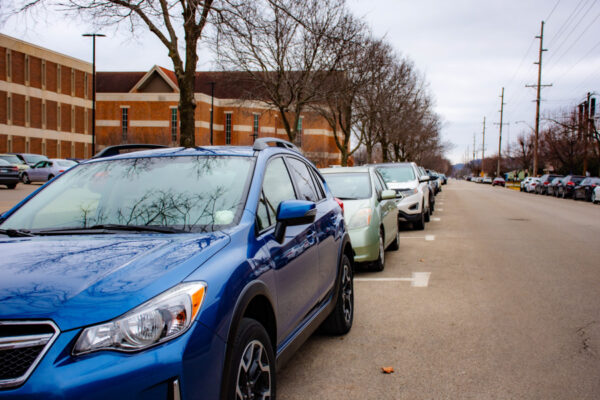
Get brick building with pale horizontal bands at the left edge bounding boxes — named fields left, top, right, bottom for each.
left=0, top=34, right=92, bottom=158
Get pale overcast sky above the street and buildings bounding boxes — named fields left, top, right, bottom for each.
left=0, top=0, right=600, bottom=163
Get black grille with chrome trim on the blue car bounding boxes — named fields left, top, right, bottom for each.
left=0, top=321, right=59, bottom=388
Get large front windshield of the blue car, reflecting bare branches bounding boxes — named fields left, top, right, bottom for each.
left=0, top=156, right=254, bottom=232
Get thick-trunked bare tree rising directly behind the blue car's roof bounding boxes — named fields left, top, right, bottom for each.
left=9, top=0, right=216, bottom=147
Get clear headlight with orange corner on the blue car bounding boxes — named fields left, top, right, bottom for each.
left=73, top=282, right=206, bottom=355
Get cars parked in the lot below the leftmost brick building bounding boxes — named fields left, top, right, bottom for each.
left=0, top=153, right=77, bottom=189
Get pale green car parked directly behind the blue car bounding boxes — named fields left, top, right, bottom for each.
left=321, top=167, right=400, bottom=271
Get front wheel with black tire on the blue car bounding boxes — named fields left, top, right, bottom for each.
left=223, top=318, right=276, bottom=400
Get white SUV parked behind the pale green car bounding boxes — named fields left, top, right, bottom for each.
left=376, top=162, right=431, bottom=230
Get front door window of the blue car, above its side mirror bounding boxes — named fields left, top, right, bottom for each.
left=256, top=157, right=296, bottom=231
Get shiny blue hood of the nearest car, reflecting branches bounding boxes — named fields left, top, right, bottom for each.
left=0, top=232, right=230, bottom=331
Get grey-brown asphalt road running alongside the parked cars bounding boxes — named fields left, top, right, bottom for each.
left=278, top=181, right=600, bottom=400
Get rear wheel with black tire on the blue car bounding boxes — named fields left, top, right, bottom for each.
left=321, top=254, right=354, bottom=335
